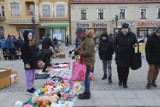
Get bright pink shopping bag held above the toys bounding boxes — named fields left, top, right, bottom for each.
left=71, top=61, right=87, bottom=81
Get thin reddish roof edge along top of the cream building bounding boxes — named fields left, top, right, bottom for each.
left=70, top=0, right=160, bottom=4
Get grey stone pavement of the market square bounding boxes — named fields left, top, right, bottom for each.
left=0, top=46, right=160, bottom=107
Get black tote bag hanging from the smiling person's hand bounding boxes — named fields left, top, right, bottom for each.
left=131, top=44, right=142, bottom=70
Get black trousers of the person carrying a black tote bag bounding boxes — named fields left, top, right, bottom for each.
left=117, top=66, right=129, bottom=84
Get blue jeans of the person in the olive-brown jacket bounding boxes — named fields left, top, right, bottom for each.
left=84, top=67, right=91, bottom=92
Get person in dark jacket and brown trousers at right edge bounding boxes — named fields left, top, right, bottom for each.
left=145, top=27, right=160, bottom=89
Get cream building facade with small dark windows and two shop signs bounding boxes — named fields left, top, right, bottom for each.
left=71, top=0, right=160, bottom=42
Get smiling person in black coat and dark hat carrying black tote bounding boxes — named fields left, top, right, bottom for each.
left=114, top=23, right=137, bottom=88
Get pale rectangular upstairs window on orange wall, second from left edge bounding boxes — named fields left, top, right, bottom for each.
left=11, top=3, right=20, bottom=16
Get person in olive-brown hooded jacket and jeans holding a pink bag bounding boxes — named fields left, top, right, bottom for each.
left=75, top=28, right=95, bottom=99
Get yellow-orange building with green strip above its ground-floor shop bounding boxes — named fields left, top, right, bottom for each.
left=0, top=0, right=69, bottom=42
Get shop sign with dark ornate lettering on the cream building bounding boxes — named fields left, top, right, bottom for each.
left=77, top=23, right=107, bottom=28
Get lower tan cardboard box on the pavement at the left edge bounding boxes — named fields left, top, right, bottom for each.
left=0, top=76, right=11, bottom=89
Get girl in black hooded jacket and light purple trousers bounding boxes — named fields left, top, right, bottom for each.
left=21, top=30, right=37, bottom=94
